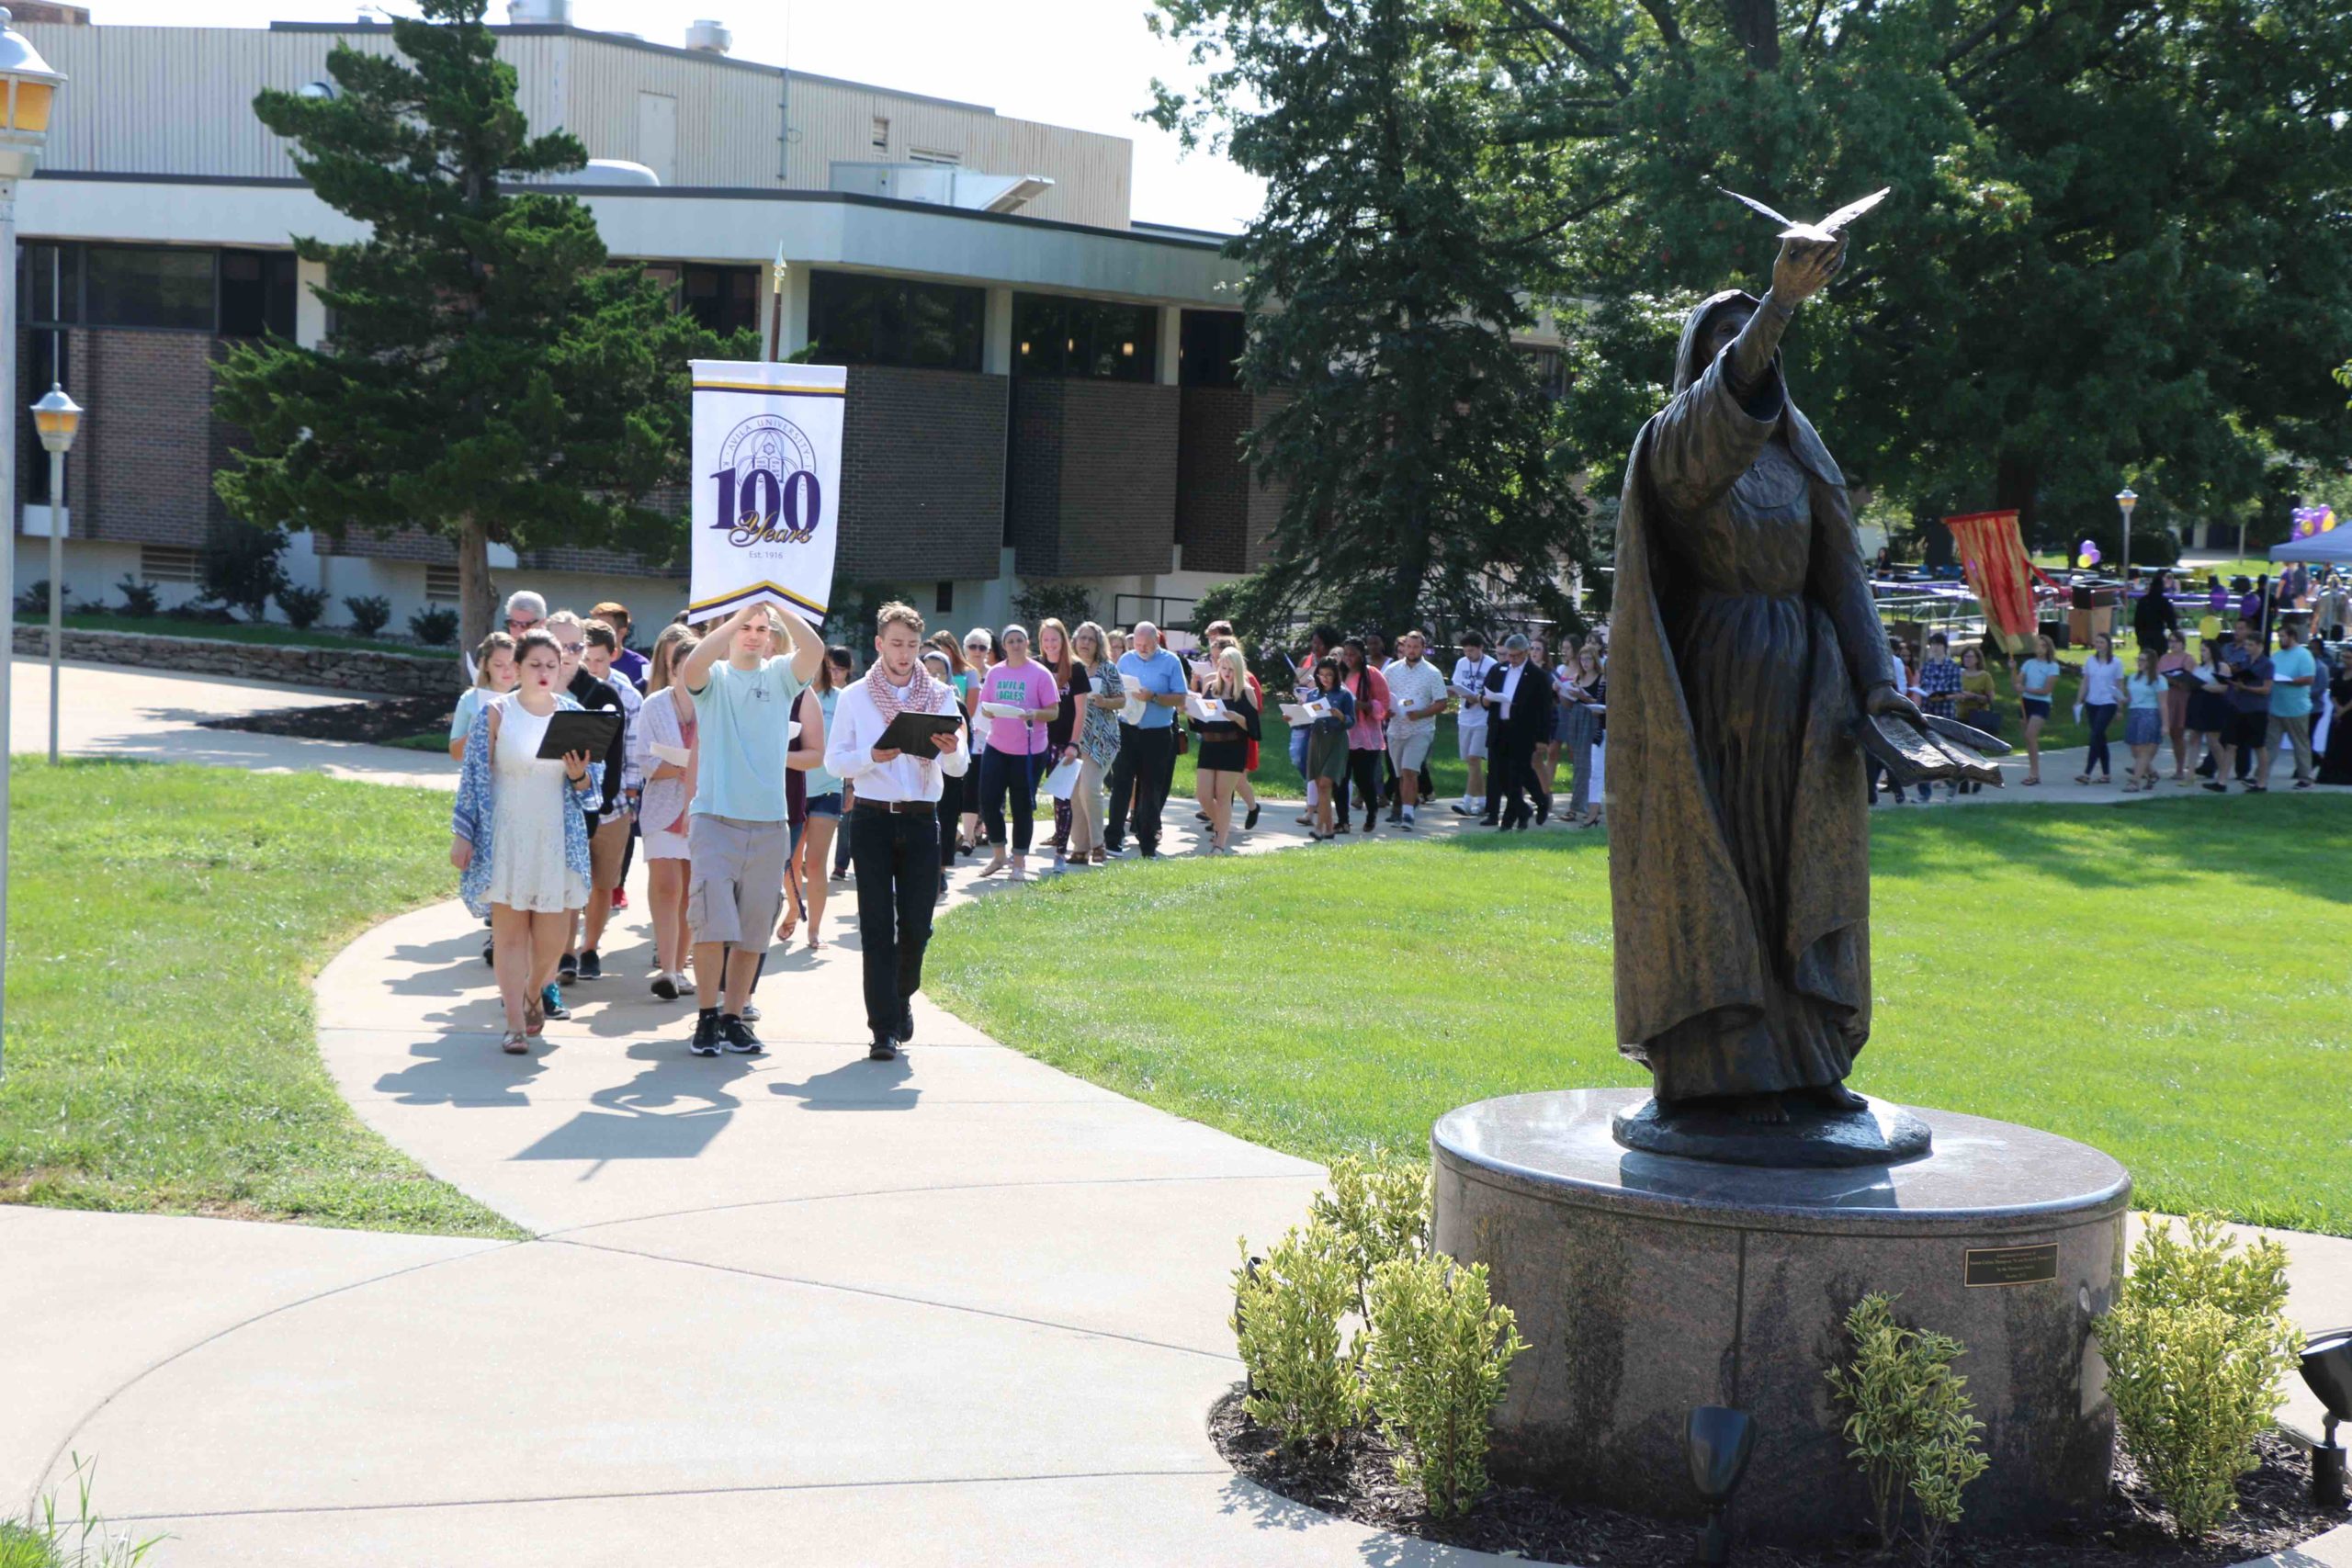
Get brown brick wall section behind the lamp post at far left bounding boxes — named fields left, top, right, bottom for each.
left=17, top=327, right=232, bottom=547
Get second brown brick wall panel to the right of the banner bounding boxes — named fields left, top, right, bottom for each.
left=1007, top=378, right=1183, bottom=576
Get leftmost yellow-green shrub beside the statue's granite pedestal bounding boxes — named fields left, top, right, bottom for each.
left=1227, top=1224, right=1362, bottom=1448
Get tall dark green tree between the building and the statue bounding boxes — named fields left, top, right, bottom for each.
left=1152, top=0, right=1583, bottom=630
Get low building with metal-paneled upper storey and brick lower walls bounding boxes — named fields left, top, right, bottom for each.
left=17, top=12, right=1275, bottom=627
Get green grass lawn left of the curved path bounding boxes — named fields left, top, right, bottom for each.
left=0, top=757, right=520, bottom=1236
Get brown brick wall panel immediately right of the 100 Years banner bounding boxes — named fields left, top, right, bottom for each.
left=832, top=365, right=1009, bottom=583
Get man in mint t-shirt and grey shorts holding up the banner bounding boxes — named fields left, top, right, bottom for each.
left=677, top=604, right=826, bottom=1055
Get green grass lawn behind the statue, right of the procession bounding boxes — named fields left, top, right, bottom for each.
left=927, top=795, right=2352, bottom=1236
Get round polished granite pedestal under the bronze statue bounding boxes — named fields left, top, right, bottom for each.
left=1430, top=1089, right=2131, bottom=1542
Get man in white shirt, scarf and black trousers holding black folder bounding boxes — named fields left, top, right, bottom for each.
left=826, top=604, right=971, bottom=1063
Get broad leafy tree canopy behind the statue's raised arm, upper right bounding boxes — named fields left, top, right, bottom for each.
left=1487, top=0, right=2352, bottom=552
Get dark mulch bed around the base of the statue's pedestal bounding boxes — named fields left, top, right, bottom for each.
left=1209, top=1384, right=2352, bottom=1568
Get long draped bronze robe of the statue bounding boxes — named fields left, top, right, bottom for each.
left=1609, top=294, right=1894, bottom=1102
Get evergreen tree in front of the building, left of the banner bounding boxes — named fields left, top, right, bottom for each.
left=214, top=0, right=755, bottom=647
